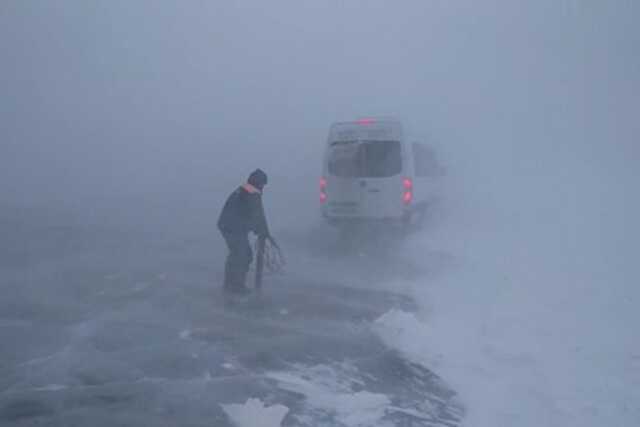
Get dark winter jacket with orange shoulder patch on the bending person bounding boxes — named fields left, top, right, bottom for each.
left=218, top=184, right=269, bottom=237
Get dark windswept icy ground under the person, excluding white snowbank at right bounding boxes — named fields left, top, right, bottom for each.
left=0, top=206, right=463, bottom=427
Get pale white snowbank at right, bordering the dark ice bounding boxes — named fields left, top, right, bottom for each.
left=378, top=137, right=640, bottom=427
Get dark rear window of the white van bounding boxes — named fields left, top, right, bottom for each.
left=328, top=141, right=402, bottom=178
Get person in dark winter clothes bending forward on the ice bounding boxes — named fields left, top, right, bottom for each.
left=218, top=169, right=269, bottom=293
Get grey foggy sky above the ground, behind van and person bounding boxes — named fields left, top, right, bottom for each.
left=0, top=0, right=640, bottom=234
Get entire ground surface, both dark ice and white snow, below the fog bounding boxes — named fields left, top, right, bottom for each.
left=0, top=163, right=640, bottom=427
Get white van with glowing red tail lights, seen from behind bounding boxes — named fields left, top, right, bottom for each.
left=320, top=118, right=441, bottom=231
